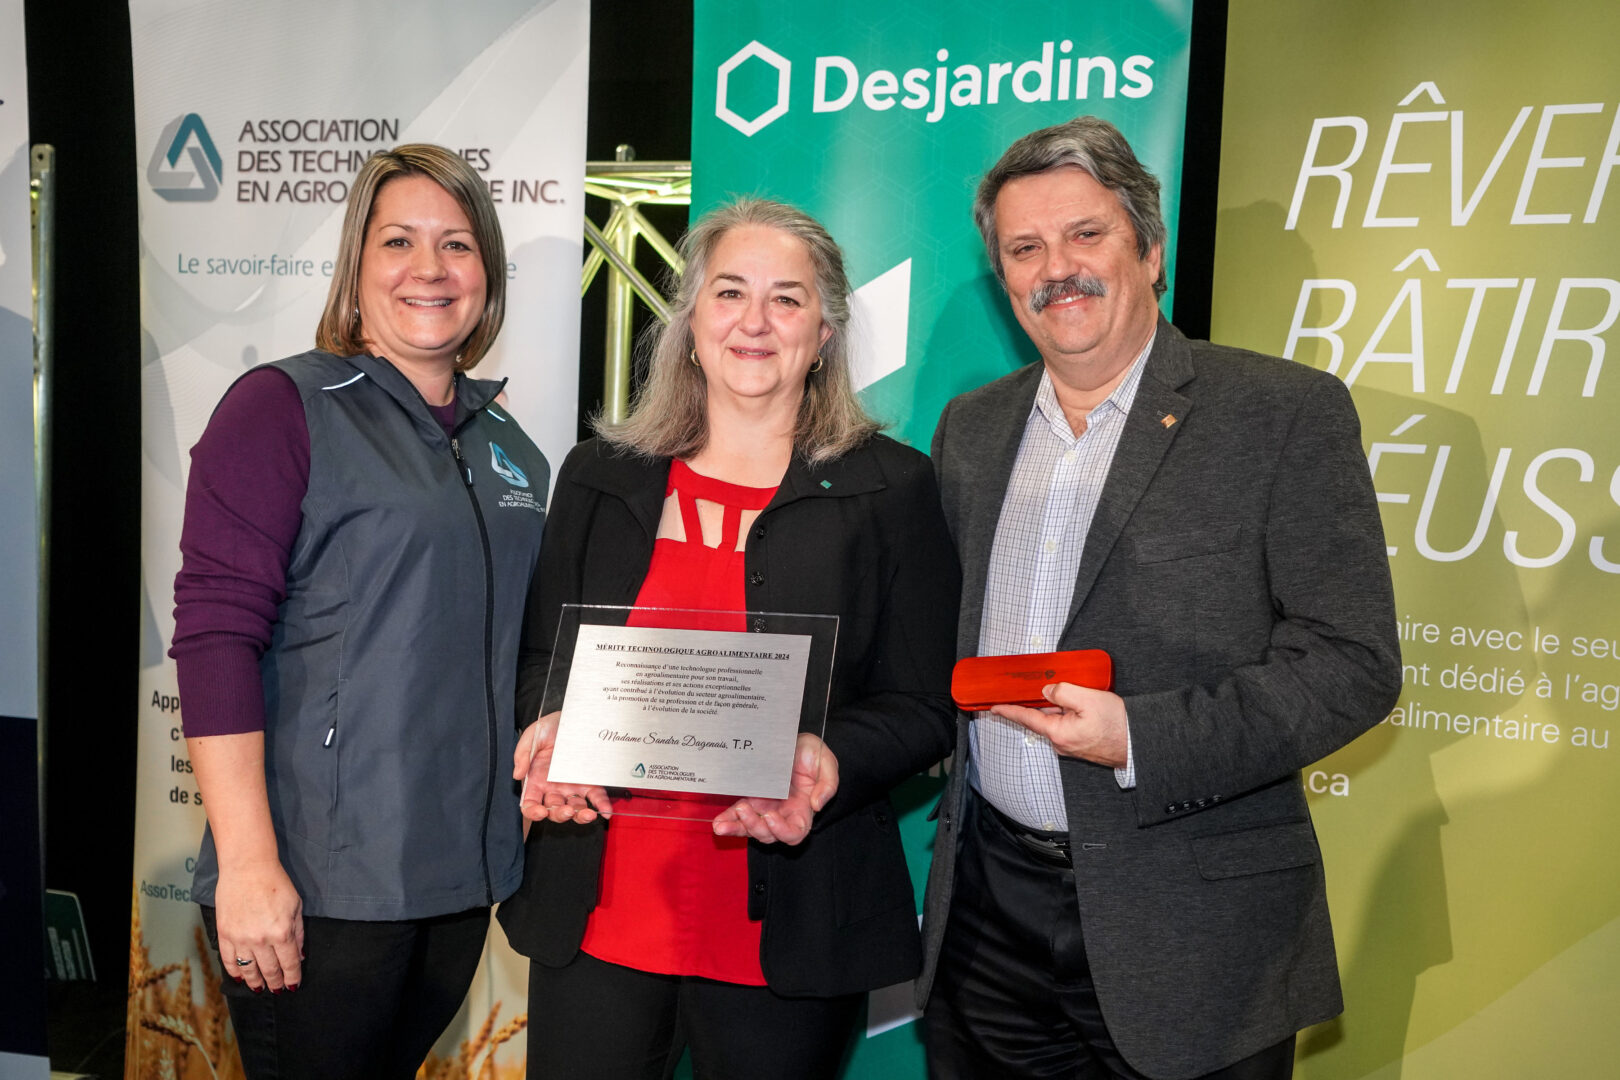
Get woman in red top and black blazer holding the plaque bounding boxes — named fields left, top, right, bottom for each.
left=501, top=199, right=959, bottom=1080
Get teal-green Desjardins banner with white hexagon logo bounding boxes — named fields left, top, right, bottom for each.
left=692, top=0, right=1192, bottom=1078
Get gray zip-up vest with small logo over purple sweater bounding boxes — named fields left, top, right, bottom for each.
left=198, top=351, right=549, bottom=920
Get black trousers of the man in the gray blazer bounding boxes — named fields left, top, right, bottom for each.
left=923, top=795, right=1294, bottom=1080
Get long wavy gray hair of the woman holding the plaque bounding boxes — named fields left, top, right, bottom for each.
left=593, top=199, right=881, bottom=465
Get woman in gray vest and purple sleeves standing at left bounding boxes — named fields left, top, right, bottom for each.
left=170, top=144, right=548, bottom=1078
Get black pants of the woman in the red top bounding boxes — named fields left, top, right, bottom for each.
left=528, top=952, right=865, bottom=1080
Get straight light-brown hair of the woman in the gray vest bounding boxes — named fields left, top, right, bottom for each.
left=314, top=142, right=505, bottom=371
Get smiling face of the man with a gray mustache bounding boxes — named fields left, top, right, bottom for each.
left=996, top=165, right=1163, bottom=387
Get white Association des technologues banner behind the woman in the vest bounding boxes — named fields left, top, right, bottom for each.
left=125, top=0, right=590, bottom=1080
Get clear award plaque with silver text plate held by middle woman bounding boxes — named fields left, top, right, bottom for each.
left=525, top=604, right=838, bottom=821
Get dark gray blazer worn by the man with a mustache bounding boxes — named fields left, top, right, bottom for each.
left=917, top=321, right=1401, bottom=1080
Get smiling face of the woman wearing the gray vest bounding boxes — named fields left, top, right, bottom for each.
left=360, top=175, right=484, bottom=366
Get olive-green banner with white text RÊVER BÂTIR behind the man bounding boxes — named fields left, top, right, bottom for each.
left=1213, top=0, right=1620, bottom=1080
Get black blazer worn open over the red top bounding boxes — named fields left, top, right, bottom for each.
left=499, top=436, right=961, bottom=996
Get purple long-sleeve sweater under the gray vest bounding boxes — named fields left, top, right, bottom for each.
left=168, top=368, right=455, bottom=737
